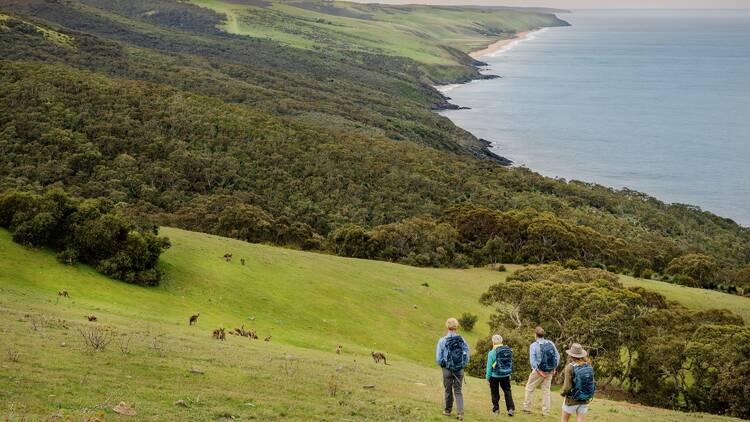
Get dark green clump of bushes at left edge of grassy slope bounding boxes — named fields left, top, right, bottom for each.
left=0, top=190, right=169, bottom=286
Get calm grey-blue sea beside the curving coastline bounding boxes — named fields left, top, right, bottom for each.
left=445, top=11, right=750, bottom=226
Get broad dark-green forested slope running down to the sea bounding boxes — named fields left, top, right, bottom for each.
left=0, top=0, right=750, bottom=290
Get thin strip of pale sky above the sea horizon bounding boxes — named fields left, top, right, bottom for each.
left=356, top=0, right=750, bottom=9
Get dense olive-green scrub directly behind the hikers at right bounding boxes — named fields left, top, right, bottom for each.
left=470, top=265, right=750, bottom=418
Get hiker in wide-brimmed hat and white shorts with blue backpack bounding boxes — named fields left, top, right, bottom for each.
left=560, top=343, right=596, bottom=422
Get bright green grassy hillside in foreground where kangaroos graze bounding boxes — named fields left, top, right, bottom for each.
left=0, top=228, right=750, bottom=421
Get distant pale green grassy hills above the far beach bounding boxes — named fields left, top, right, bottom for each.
left=193, top=0, right=568, bottom=64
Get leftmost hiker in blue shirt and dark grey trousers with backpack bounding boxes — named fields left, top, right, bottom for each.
left=435, top=318, right=469, bottom=421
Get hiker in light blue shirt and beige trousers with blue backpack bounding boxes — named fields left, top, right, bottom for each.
left=523, top=327, right=560, bottom=416
